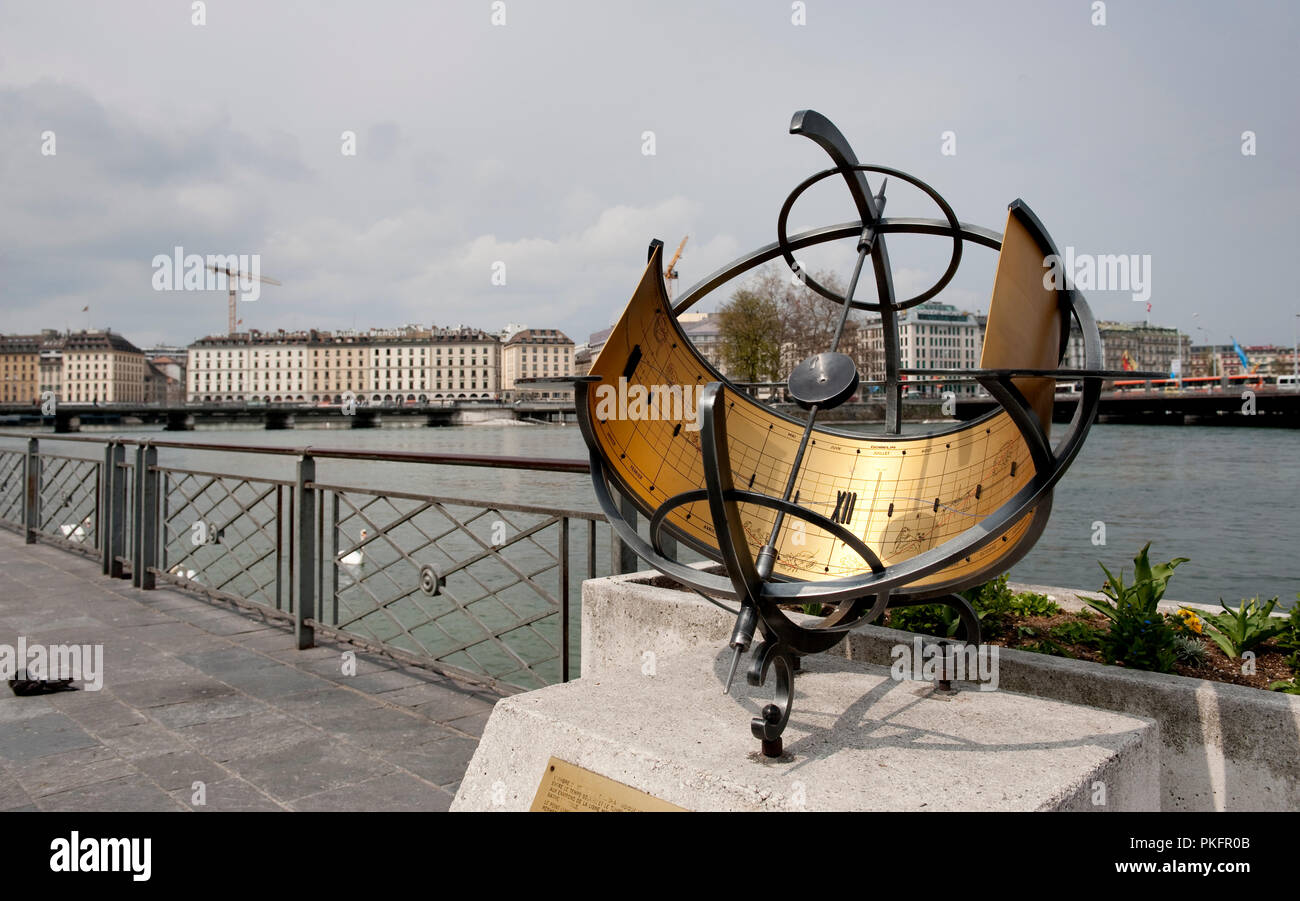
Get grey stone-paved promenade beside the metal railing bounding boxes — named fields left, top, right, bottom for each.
left=0, top=530, right=498, bottom=810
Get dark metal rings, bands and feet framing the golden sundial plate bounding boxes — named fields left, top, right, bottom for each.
left=573, top=111, right=1138, bottom=757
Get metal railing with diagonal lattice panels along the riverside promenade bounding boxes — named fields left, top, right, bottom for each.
left=0, top=432, right=636, bottom=690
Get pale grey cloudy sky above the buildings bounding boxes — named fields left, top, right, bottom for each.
left=0, top=0, right=1300, bottom=347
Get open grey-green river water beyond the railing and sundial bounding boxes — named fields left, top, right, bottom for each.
left=15, top=424, right=1300, bottom=606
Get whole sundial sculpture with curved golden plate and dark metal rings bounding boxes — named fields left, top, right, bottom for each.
left=559, top=111, right=1149, bottom=755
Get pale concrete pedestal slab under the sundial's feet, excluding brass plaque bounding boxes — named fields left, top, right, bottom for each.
left=451, top=645, right=1160, bottom=810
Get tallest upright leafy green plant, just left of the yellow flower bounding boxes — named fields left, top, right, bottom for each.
left=1084, top=542, right=1188, bottom=672
